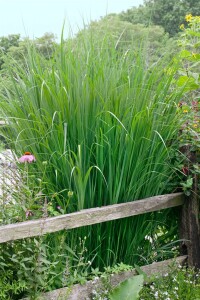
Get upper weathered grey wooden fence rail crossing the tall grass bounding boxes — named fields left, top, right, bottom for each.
left=0, top=193, right=184, bottom=243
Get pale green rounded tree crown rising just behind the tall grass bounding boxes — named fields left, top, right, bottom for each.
left=77, top=14, right=177, bottom=65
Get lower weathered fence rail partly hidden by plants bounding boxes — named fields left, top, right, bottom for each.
left=22, top=256, right=187, bottom=300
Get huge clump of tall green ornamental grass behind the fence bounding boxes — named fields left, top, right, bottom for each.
left=1, top=35, right=183, bottom=266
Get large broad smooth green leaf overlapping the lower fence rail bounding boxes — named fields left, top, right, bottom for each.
left=110, top=275, right=144, bottom=300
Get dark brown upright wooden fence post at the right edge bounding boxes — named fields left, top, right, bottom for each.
left=180, top=148, right=200, bottom=269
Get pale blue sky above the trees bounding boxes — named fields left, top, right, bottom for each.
left=0, top=0, right=143, bottom=39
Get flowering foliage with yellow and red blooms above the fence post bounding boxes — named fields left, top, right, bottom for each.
left=172, top=14, right=200, bottom=196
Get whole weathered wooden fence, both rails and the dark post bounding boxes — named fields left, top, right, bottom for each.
left=0, top=193, right=200, bottom=300
